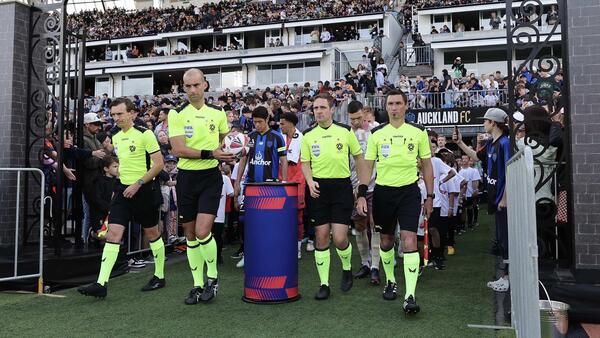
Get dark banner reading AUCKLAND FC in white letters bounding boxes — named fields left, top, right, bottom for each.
left=406, top=107, right=490, bottom=127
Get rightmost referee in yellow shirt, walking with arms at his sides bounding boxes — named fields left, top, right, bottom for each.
left=357, top=90, right=434, bottom=313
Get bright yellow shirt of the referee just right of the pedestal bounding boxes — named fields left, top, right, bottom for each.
left=300, top=122, right=362, bottom=178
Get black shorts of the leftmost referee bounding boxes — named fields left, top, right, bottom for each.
left=108, top=183, right=159, bottom=228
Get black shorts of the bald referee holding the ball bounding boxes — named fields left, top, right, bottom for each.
left=175, top=167, right=223, bottom=223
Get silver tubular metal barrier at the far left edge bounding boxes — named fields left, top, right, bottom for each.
left=0, top=168, right=46, bottom=294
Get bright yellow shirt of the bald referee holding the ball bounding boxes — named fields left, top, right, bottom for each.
left=169, top=102, right=229, bottom=170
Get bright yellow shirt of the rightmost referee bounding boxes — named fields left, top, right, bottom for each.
left=365, top=123, right=431, bottom=187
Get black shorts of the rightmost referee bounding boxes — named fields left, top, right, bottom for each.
left=373, top=183, right=421, bottom=235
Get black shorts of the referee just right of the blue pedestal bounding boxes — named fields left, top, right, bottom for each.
left=305, top=178, right=354, bottom=226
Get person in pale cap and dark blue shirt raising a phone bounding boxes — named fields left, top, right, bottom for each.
left=452, top=108, right=510, bottom=292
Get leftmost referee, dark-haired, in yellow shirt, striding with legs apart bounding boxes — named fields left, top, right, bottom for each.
left=77, top=98, right=165, bottom=298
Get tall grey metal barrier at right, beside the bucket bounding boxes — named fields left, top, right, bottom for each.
left=506, top=146, right=540, bottom=337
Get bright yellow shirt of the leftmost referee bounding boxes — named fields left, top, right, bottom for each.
left=112, top=126, right=160, bottom=185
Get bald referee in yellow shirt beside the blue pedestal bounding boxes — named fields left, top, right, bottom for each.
left=169, top=68, right=233, bottom=305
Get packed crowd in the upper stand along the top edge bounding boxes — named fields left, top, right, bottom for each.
left=68, top=0, right=389, bottom=40
